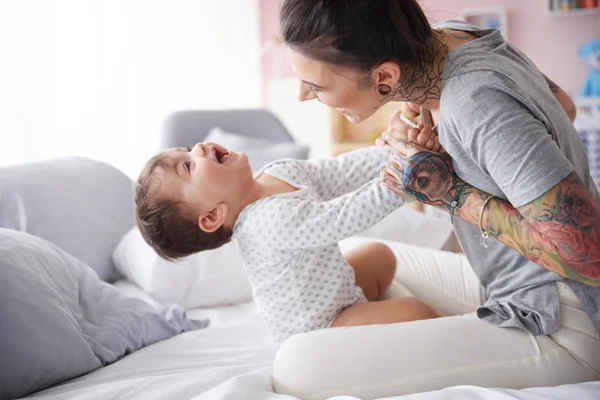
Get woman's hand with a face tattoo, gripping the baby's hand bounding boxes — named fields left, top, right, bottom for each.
left=382, top=140, right=464, bottom=205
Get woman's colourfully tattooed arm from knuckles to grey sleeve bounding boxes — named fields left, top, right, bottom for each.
left=384, top=143, right=600, bottom=286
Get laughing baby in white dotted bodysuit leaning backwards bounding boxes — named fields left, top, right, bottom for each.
left=135, top=129, right=438, bottom=342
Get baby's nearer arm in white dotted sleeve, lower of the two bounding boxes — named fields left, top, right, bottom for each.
left=272, top=177, right=405, bottom=250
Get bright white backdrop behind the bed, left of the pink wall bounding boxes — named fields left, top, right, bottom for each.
left=0, top=0, right=261, bottom=177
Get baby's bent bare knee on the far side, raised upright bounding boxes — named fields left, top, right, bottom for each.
left=344, top=242, right=396, bottom=301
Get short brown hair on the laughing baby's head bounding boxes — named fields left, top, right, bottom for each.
left=134, top=154, right=232, bottom=260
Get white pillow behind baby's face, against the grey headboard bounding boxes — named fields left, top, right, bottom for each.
left=204, top=126, right=309, bottom=172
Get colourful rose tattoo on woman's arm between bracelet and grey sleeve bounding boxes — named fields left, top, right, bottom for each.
left=487, top=173, right=600, bottom=286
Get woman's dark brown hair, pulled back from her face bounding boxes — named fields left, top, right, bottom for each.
left=280, top=0, right=434, bottom=80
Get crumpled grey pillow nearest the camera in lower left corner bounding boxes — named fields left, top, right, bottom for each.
left=0, top=228, right=208, bottom=400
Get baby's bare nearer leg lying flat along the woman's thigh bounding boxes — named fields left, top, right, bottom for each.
left=331, top=297, right=440, bottom=327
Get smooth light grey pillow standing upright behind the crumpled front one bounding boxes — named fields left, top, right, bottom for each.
left=0, top=157, right=133, bottom=282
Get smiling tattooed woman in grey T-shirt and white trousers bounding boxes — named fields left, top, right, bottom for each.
left=274, top=0, right=600, bottom=398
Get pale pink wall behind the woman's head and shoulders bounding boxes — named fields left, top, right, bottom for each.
left=259, top=0, right=600, bottom=101
